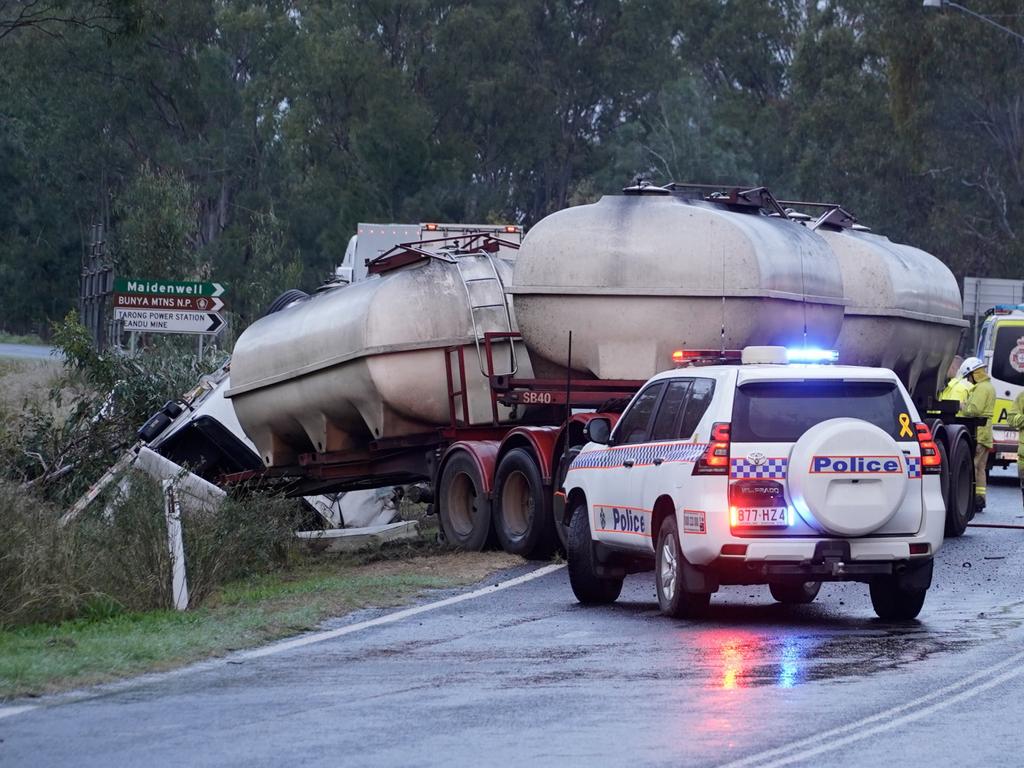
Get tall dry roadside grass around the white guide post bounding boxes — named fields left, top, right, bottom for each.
left=0, top=474, right=302, bottom=628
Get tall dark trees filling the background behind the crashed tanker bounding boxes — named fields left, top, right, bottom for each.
left=0, top=0, right=1024, bottom=333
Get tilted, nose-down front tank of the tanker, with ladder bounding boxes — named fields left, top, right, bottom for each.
left=227, top=252, right=532, bottom=466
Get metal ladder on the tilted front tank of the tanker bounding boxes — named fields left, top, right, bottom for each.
left=455, top=250, right=519, bottom=377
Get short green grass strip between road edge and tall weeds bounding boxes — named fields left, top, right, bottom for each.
left=0, top=545, right=522, bottom=697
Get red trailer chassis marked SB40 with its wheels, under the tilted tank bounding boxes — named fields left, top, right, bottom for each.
left=223, top=332, right=644, bottom=559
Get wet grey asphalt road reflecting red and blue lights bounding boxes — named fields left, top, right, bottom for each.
left=0, top=473, right=1024, bottom=768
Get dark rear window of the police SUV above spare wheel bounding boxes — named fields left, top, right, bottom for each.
left=731, top=380, right=906, bottom=442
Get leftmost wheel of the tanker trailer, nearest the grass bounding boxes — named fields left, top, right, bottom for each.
left=437, top=453, right=490, bottom=552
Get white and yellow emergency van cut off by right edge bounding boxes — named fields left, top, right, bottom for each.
left=977, top=304, right=1024, bottom=467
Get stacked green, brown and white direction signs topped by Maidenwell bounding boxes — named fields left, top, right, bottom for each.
left=114, top=278, right=224, bottom=335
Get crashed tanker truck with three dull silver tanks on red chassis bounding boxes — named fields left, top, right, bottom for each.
left=227, top=184, right=976, bottom=557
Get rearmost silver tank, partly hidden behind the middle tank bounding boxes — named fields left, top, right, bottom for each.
left=817, top=227, right=968, bottom=395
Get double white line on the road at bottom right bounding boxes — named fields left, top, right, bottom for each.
left=720, top=652, right=1024, bottom=768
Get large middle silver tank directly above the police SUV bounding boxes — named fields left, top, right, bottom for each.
left=510, top=195, right=844, bottom=379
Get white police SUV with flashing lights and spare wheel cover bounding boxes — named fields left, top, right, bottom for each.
left=563, top=347, right=945, bottom=620
